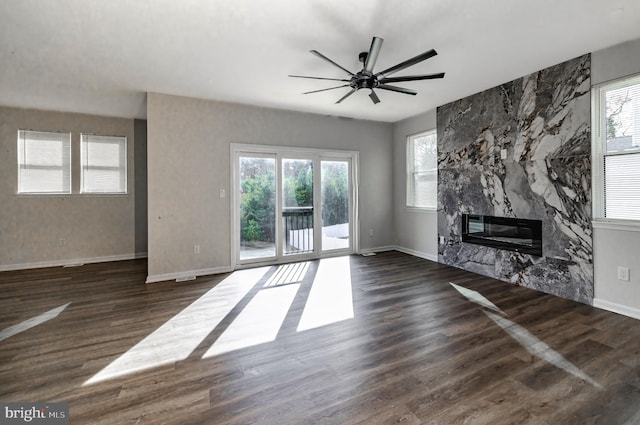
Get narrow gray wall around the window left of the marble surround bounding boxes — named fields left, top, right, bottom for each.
left=393, top=110, right=438, bottom=261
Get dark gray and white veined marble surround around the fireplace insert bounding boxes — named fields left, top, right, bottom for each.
left=437, top=55, right=593, bottom=304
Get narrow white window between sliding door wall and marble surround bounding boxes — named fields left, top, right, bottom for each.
left=407, top=130, right=438, bottom=209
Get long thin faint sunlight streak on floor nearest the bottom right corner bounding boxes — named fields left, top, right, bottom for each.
left=484, top=311, right=602, bottom=388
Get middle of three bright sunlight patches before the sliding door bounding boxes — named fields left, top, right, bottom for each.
left=202, top=284, right=300, bottom=359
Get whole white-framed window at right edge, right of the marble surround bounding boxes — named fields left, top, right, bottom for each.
left=593, top=72, right=640, bottom=220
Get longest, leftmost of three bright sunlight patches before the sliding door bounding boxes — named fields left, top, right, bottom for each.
left=84, top=267, right=269, bottom=385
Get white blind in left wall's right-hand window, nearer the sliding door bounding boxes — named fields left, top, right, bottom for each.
left=80, top=134, right=127, bottom=193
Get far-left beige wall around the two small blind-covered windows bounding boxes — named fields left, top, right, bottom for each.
left=0, top=107, right=145, bottom=270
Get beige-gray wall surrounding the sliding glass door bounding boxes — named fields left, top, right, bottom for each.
left=147, top=93, right=393, bottom=281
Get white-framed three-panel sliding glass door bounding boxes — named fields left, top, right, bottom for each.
left=232, top=145, right=357, bottom=264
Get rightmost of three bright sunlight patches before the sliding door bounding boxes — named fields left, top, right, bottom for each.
left=297, top=256, right=354, bottom=332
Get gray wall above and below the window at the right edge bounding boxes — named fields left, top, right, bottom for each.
left=591, top=40, right=640, bottom=319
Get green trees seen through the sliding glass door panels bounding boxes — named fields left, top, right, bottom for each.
left=240, top=158, right=349, bottom=243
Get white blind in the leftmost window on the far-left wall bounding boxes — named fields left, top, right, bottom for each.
left=18, top=130, right=71, bottom=193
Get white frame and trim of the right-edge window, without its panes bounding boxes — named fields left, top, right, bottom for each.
left=591, top=74, right=640, bottom=227
